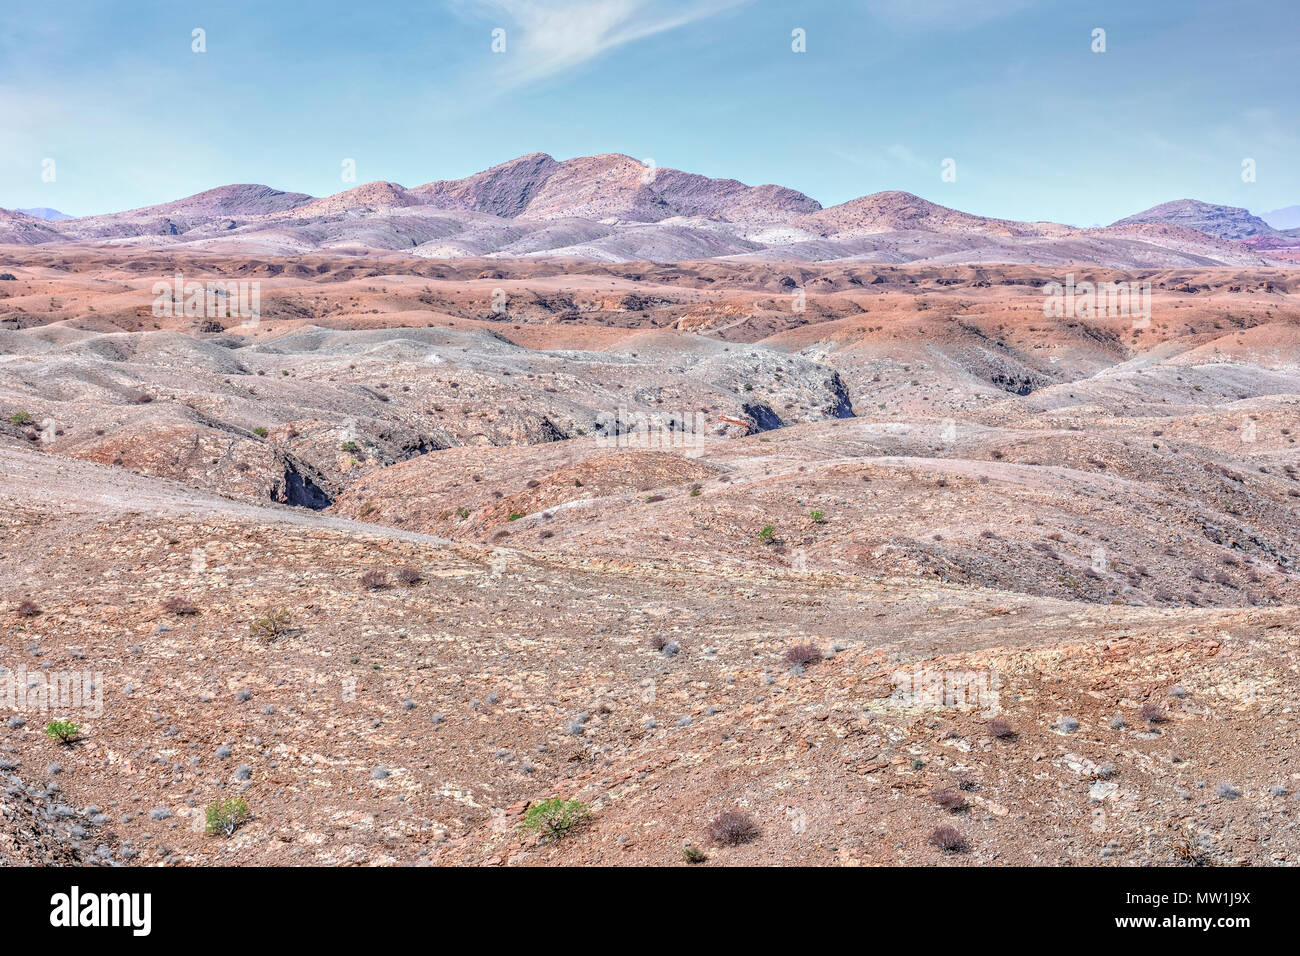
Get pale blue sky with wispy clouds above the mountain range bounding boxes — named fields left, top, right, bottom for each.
left=0, top=0, right=1300, bottom=225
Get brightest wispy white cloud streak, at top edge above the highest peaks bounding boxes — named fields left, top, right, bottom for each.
left=454, top=0, right=750, bottom=86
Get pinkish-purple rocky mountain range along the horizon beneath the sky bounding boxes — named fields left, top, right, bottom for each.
left=0, top=153, right=1300, bottom=268
